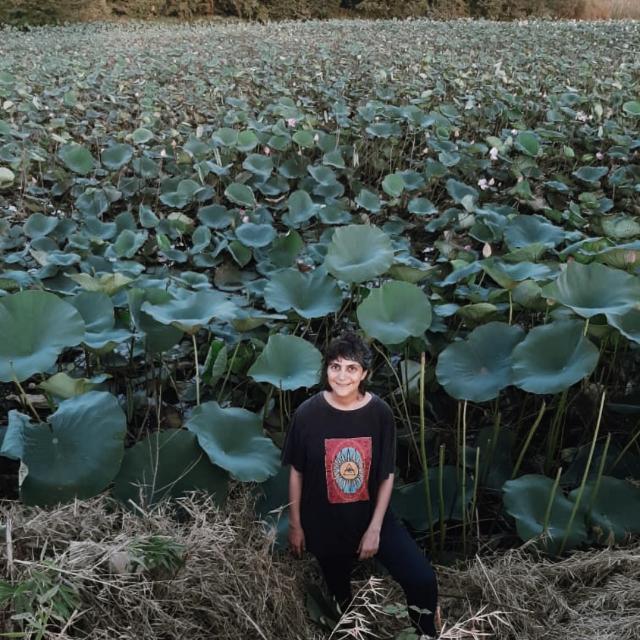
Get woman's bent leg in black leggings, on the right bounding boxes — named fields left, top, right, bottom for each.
left=376, top=514, right=438, bottom=637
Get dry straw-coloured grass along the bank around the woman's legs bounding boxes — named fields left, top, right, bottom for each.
left=0, top=491, right=640, bottom=640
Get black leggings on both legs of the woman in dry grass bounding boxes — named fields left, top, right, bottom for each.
left=316, top=514, right=438, bottom=636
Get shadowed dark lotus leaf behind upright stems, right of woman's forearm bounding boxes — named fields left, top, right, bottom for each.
left=391, top=465, right=473, bottom=531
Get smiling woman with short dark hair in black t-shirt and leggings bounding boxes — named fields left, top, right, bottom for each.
left=282, top=333, right=438, bottom=636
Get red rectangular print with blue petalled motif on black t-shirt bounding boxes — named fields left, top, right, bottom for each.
left=324, top=436, right=371, bottom=504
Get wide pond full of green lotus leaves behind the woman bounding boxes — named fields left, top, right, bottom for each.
left=0, top=20, right=640, bottom=554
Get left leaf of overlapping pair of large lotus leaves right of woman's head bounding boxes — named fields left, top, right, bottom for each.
left=436, top=322, right=524, bottom=402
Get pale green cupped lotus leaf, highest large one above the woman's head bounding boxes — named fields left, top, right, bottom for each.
left=324, top=224, right=393, bottom=282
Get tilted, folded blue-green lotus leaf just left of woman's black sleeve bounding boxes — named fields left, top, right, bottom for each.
left=186, top=402, right=280, bottom=482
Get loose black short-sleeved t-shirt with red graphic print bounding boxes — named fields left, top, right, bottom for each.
left=282, top=392, right=395, bottom=555
